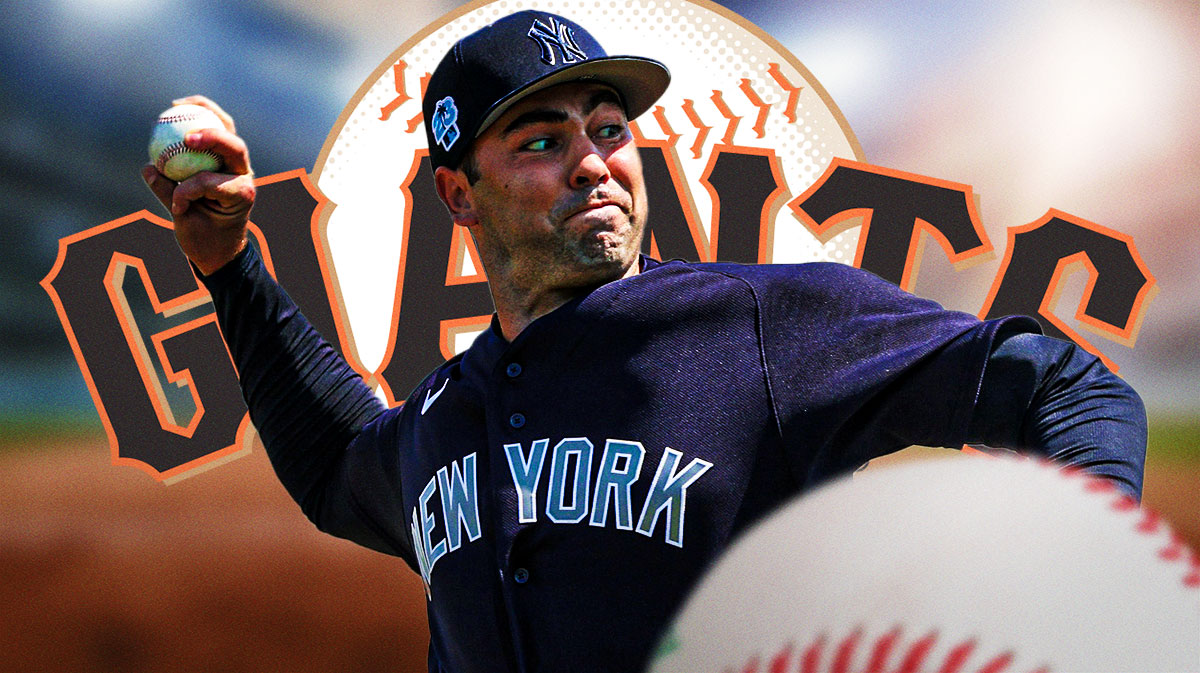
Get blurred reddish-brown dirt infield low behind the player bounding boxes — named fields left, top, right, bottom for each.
left=0, top=443, right=1200, bottom=673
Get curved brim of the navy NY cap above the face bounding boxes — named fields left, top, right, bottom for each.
left=475, top=56, right=671, bottom=138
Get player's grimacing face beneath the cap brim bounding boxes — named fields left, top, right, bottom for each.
left=458, top=83, right=647, bottom=292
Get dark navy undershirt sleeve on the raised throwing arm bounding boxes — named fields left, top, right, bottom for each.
left=197, top=238, right=413, bottom=559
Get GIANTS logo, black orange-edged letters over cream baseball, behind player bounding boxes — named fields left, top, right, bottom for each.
left=42, top=0, right=1154, bottom=482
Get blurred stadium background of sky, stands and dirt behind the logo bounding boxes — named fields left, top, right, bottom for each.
left=0, top=0, right=1200, bottom=671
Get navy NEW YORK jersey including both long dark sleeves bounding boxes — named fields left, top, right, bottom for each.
left=205, top=250, right=1145, bottom=671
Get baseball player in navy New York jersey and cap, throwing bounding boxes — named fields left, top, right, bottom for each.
left=144, top=11, right=1146, bottom=671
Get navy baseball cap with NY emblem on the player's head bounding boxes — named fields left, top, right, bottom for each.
left=421, top=10, right=671, bottom=168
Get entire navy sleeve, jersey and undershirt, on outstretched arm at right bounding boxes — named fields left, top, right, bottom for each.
left=756, top=264, right=1145, bottom=494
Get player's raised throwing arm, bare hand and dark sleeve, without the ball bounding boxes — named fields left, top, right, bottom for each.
left=142, top=96, right=412, bottom=559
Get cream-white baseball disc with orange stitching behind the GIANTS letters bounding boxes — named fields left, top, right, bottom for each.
left=313, top=0, right=860, bottom=369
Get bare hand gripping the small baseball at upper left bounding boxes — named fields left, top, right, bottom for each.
left=142, top=96, right=254, bottom=276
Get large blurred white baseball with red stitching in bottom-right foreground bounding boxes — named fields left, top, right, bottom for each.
left=652, top=457, right=1200, bottom=673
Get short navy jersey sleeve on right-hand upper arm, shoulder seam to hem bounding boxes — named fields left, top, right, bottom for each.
left=750, top=257, right=1022, bottom=472
